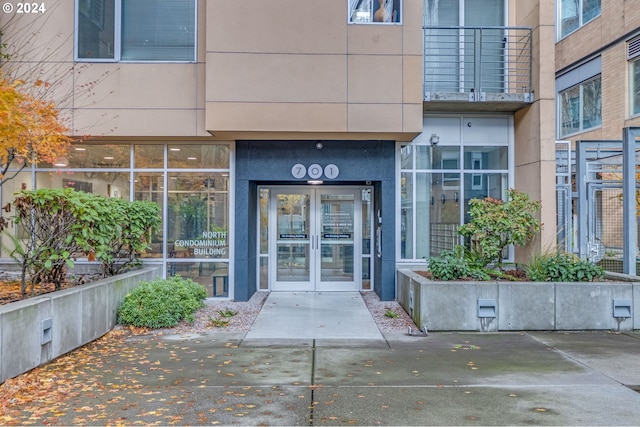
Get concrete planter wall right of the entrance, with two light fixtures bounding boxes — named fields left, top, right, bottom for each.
left=396, top=269, right=640, bottom=331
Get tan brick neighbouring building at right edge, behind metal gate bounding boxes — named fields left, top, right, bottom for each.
left=555, top=0, right=640, bottom=272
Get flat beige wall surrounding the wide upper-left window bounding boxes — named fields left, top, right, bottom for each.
left=0, top=0, right=210, bottom=138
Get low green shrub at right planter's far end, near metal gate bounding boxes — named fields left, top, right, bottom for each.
left=526, top=253, right=604, bottom=282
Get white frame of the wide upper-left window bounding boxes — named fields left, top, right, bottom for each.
left=73, top=0, right=198, bottom=64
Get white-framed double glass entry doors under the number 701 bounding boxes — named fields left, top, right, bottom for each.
left=269, top=187, right=362, bottom=291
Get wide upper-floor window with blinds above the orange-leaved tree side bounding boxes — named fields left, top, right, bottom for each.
left=76, top=0, right=196, bottom=62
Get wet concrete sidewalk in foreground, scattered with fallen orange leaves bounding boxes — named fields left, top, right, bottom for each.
left=5, top=332, right=640, bottom=426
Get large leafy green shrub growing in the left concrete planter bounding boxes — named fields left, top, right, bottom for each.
left=9, top=188, right=160, bottom=294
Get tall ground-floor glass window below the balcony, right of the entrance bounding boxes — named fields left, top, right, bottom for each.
left=399, top=122, right=509, bottom=262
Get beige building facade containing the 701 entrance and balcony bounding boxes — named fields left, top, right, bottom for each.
left=0, top=0, right=556, bottom=300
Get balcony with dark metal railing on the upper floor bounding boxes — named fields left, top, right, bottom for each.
left=423, top=27, right=534, bottom=112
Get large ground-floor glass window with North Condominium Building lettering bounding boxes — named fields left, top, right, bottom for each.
left=0, top=141, right=231, bottom=297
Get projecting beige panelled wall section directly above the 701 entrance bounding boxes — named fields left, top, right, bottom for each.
left=206, top=0, right=422, bottom=140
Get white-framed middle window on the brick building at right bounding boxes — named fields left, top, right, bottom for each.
left=558, top=76, right=602, bottom=137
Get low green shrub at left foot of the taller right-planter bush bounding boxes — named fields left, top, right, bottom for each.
left=427, top=245, right=489, bottom=280
